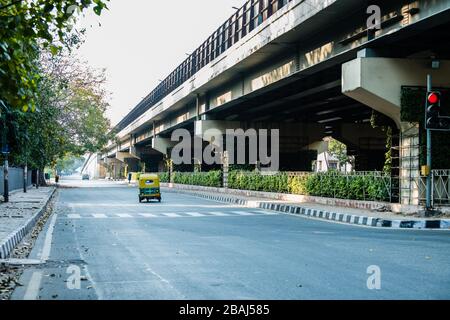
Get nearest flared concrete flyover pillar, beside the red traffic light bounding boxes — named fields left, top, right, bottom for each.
left=342, top=57, right=450, bottom=205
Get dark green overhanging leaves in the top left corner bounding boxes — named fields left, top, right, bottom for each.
left=0, top=0, right=106, bottom=112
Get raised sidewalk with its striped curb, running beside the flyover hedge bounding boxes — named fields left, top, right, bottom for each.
left=164, top=185, right=450, bottom=230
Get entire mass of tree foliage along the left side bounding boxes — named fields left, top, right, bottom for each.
left=0, top=0, right=109, bottom=175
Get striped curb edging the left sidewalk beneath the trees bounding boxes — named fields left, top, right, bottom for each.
left=0, top=188, right=56, bottom=259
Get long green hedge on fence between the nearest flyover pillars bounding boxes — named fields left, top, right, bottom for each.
left=228, top=171, right=390, bottom=201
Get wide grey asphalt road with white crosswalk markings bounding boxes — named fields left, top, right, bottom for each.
left=9, top=182, right=450, bottom=300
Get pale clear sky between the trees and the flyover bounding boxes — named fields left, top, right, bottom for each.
left=78, top=0, right=245, bottom=125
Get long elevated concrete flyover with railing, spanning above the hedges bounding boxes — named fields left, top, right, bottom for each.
left=103, top=0, right=450, bottom=203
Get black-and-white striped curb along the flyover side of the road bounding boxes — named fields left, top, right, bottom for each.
left=169, top=189, right=450, bottom=230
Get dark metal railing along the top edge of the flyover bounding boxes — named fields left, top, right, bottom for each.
left=115, top=0, right=293, bottom=131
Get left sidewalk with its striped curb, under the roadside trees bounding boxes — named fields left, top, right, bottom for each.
left=0, top=187, right=56, bottom=259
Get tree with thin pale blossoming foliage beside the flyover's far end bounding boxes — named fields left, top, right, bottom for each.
left=4, top=46, right=111, bottom=181
